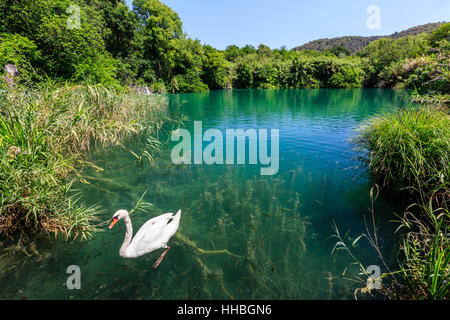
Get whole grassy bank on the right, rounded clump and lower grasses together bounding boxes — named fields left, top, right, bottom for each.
left=344, top=107, right=450, bottom=299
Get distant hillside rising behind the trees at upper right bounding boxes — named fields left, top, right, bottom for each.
left=293, top=22, right=445, bottom=53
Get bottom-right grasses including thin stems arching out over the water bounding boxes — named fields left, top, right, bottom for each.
left=332, top=182, right=450, bottom=300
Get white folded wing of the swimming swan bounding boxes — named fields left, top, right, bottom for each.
left=130, top=213, right=172, bottom=256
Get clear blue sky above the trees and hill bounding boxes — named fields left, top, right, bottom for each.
left=126, top=0, right=450, bottom=49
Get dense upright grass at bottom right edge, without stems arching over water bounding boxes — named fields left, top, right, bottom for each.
left=393, top=186, right=450, bottom=300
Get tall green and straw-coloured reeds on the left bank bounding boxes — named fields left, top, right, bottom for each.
left=0, top=85, right=166, bottom=244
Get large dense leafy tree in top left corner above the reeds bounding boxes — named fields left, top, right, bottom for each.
left=0, top=0, right=115, bottom=81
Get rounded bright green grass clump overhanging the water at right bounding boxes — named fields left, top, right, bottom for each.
left=355, top=107, right=450, bottom=196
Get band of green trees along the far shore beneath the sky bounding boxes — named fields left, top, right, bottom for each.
left=0, top=0, right=450, bottom=94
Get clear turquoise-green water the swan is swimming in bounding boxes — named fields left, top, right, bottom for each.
left=0, top=89, right=407, bottom=299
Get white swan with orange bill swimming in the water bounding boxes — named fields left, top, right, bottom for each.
left=109, top=210, right=181, bottom=268
